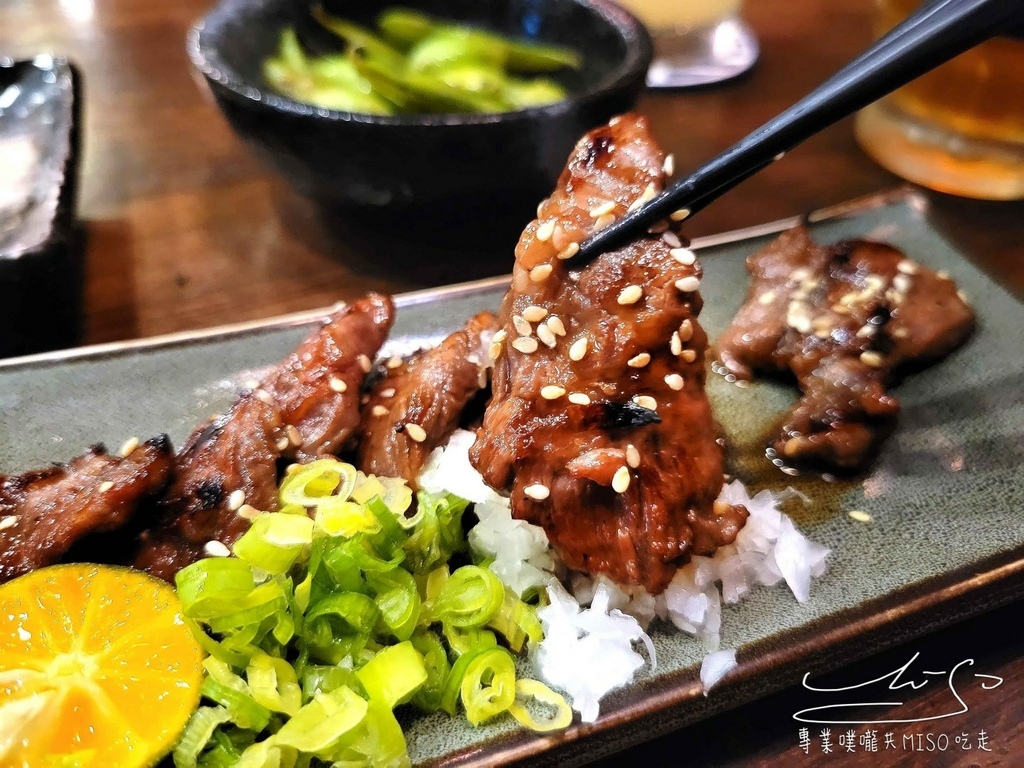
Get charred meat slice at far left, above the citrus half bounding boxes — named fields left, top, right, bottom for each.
left=0, top=435, right=173, bottom=583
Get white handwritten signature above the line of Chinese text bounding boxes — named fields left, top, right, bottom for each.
left=793, top=652, right=1002, bottom=725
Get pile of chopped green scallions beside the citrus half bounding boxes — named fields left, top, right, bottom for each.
left=174, top=459, right=571, bottom=768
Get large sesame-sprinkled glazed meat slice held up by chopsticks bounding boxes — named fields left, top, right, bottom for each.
left=471, top=115, right=746, bottom=592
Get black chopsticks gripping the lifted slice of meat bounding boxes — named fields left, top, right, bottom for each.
left=566, top=0, right=1024, bottom=269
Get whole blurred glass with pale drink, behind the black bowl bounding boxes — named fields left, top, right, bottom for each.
left=606, top=0, right=760, bottom=88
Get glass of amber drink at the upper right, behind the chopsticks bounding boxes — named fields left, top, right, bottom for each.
left=855, top=0, right=1024, bottom=200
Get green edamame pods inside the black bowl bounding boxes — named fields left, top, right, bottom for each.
left=263, top=7, right=581, bottom=115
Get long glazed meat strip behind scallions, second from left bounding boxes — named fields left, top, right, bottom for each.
left=141, top=294, right=394, bottom=581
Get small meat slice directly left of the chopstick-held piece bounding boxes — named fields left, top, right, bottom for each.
left=358, top=312, right=498, bottom=488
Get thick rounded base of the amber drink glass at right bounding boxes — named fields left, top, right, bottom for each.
left=854, top=101, right=1024, bottom=200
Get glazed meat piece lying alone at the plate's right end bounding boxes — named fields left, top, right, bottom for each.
left=718, top=227, right=974, bottom=471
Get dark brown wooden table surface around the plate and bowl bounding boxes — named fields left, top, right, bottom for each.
left=0, top=0, right=1024, bottom=766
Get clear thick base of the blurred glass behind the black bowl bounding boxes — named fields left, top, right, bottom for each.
left=647, top=17, right=761, bottom=88
